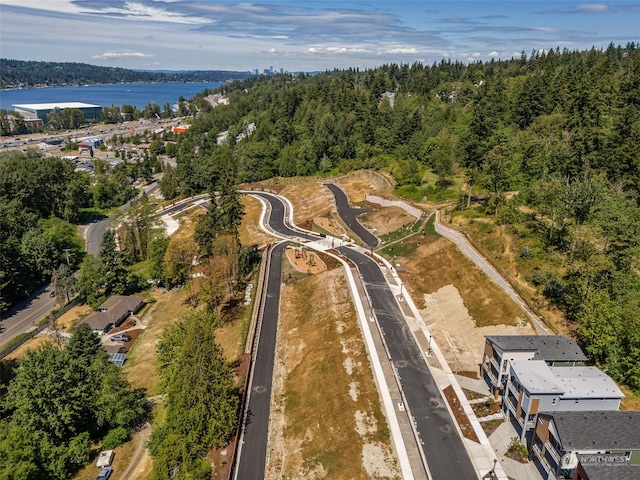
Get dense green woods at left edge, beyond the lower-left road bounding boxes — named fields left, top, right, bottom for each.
left=0, top=149, right=161, bottom=313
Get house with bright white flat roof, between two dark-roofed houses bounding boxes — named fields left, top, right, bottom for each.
left=502, top=360, right=624, bottom=444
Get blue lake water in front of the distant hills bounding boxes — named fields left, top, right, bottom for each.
left=0, top=82, right=222, bottom=110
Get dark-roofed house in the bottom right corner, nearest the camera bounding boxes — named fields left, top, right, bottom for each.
left=530, top=411, right=640, bottom=480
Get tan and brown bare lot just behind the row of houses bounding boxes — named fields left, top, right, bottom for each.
left=395, top=235, right=535, bottom=371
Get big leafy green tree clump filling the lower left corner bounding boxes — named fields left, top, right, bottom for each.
left=0, top=325, right=146, bottom=480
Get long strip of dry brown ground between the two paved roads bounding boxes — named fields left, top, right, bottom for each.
left=266, top=269, right=399, bottom=479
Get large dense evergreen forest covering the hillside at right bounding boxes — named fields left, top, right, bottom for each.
left=163, top=43, right=640, bottom=389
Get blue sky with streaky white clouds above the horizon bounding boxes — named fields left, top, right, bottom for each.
left=0, top=0, right=640, bottom=71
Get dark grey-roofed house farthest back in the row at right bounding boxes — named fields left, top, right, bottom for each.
left=480, top=335, right=587, bottom=398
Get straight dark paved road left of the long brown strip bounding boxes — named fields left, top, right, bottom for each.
left=233, top=242, right=288, bottom=480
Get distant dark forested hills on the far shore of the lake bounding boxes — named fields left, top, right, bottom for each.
left=0, top=58, right=252, bottom=90
